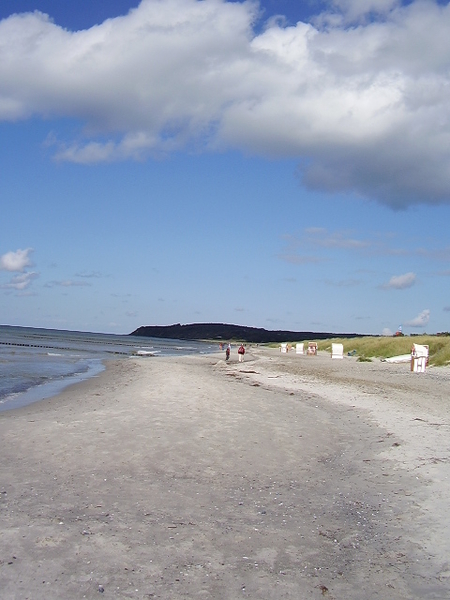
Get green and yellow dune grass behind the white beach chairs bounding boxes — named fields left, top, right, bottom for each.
left=317, top=335, right=450, bottom=366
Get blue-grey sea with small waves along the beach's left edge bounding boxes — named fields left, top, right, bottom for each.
left=0, top=325, right=217, bottom=411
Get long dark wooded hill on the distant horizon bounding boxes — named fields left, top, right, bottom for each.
left=130, top=323, right=362, bottom=344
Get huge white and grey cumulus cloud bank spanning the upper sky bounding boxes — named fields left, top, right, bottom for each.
left=0, top=0, right=450, bottom=208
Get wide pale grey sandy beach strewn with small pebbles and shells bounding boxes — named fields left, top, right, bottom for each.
left=0, top=348, right=450, bottom=600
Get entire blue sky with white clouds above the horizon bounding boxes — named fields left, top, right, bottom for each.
left=0, top=0, right=450, bottom=334
